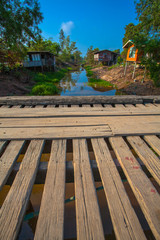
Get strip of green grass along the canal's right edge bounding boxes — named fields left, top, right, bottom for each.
left=84, top=66, right=113, bottom=88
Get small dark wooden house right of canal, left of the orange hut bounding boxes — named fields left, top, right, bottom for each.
left=94, top=50, right=119, bottom=66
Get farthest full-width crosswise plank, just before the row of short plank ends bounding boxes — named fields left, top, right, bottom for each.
left=0, top=107, right=160, bottom=118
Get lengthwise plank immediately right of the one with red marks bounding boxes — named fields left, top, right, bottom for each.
left=127, top=136, right=160, bottom=184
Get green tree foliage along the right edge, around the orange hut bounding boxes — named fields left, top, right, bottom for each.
left=121, top=0, right=160, bottom=87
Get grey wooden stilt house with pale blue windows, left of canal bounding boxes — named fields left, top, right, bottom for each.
left=23, top=51, right=55, bottom=70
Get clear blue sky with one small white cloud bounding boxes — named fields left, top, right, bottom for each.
left=40, top=0, right=137, bottom=55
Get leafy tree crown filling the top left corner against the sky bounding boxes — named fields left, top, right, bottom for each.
left=0, top=0, right=43, bottom=47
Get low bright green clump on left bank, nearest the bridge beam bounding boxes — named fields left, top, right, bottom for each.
left=31, top=83, right=59, bottom=96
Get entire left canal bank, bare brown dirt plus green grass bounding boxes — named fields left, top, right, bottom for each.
left=0, top=67, right=73, bottom=97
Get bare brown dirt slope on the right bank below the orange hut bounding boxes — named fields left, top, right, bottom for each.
left=91, top=65, right=160, bottom=96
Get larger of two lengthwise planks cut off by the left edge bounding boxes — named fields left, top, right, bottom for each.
left=0, top=141, right=24, bottom=190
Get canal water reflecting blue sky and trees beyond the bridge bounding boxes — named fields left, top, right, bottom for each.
left=60, top=69, right=116, bottom=96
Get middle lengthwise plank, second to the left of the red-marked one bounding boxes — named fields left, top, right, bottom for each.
left=73, top=139, right=104, bottom=240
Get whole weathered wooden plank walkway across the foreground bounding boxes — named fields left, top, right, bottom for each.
left=0, top=96, right=160, bottom=240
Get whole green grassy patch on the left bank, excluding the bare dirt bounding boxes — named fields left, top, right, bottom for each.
left=31, top=67, right=72, bottom=96
